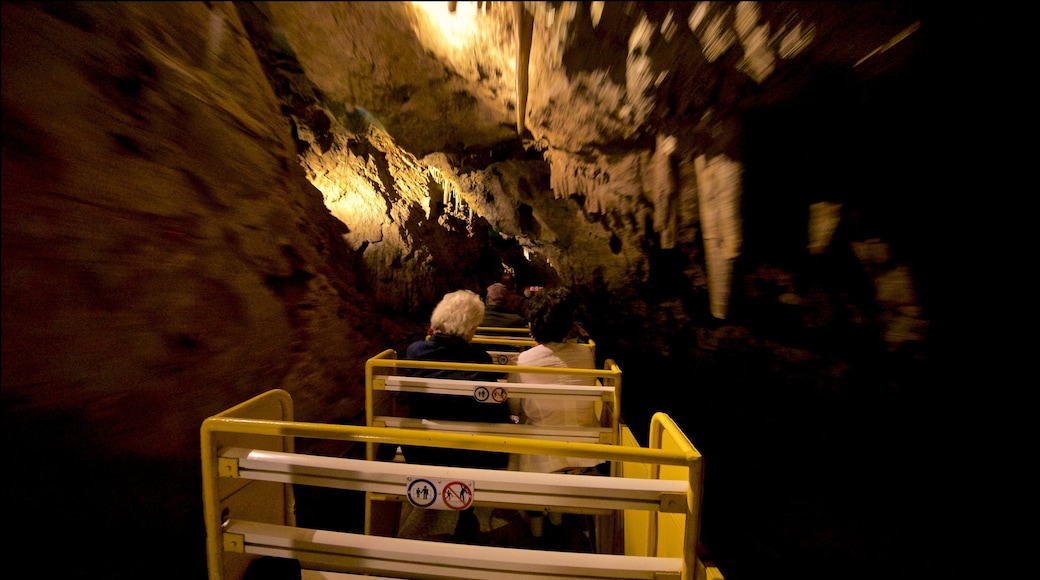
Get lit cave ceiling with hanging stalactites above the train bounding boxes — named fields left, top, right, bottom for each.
left=238, top=2, right=929, bottom=318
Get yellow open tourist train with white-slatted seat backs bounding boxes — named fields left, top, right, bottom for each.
left=202, top=346, right=722, bottom=580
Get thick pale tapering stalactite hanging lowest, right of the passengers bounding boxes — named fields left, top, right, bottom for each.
left=695, top=155, right=743, bottom=319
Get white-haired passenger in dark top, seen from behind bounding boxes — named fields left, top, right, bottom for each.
left=401, top=290, right=513, bottom=542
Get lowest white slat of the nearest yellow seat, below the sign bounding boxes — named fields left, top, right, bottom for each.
left=225, top=520, right=682, bottom=580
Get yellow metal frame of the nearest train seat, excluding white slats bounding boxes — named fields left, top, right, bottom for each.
left=201, top=388, right=721, bottom=580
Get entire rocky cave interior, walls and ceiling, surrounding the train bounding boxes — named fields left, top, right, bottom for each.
left=0, top=2, right=948, bottom=578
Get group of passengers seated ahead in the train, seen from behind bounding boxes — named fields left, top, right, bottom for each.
left=401, top=276, right=605, bottom=542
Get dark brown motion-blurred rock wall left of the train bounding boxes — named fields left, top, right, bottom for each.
left=2, top=2, right=406, bottom=578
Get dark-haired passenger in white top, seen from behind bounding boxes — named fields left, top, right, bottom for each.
left=513, top=288, right=603, bottom=536
